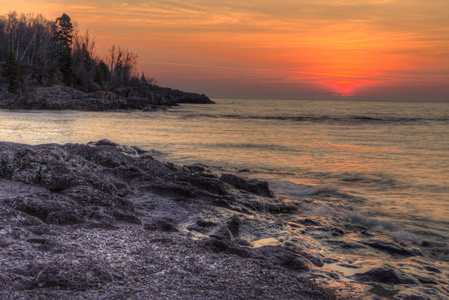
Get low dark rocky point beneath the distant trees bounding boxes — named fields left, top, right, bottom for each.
left=0, top=85, right=214, bottom=111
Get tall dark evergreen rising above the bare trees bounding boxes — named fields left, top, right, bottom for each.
left=56, top=13, right=74, bottom=85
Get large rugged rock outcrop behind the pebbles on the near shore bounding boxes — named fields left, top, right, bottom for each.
left=0, top=140, right=292, bottom=236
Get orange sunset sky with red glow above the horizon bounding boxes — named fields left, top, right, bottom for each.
left=0, top=0, right=449, bottom=102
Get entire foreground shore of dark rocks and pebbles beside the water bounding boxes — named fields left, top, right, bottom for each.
left=0, top=140, right=449, bottom=299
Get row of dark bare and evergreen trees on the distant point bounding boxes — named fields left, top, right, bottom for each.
left=0, top=12, right=156, bottom=94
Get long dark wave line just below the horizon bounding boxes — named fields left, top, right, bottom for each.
left=183, top=114, right=449, bottom=125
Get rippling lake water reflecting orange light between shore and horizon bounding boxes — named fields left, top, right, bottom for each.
left=0, top=100, right=449, bottom=246
